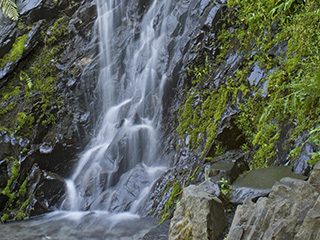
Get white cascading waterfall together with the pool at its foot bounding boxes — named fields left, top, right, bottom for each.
left=0, top=0, right=209, bottom=239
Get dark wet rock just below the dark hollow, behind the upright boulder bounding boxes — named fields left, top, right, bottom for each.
left=206, top=150, right=249, bottom=183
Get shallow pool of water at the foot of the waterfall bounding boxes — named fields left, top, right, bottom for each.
left=0, top=211, right=158, bottom=240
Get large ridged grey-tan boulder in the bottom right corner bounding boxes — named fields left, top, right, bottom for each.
left=228, top=178, right=319, bottom=240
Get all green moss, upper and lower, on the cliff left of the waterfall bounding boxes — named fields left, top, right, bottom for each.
left=0, top=17, right=68, bottom=222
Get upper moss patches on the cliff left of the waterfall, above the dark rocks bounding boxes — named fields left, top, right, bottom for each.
left=0, top=17, right=68, bottom=137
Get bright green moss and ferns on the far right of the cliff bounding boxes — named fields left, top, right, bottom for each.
left=228, top=0, right=320, bottom=167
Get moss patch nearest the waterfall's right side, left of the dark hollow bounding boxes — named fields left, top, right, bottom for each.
left=177, top=77, right=245, bottom=156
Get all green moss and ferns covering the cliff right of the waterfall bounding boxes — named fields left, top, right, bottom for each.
left=178, top=0, right=320, bottom=168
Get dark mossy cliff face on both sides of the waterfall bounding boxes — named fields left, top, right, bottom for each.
left=0, top=0, right=319, bottom=236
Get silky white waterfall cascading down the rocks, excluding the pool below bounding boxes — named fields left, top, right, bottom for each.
left=62, top=0, right=173, bottom=213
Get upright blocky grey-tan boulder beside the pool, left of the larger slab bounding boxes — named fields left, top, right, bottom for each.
left=169, top=179, right=227, bottom=240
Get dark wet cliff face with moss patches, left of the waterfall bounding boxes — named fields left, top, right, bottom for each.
left=0, top=1, right=98, bottom=221
